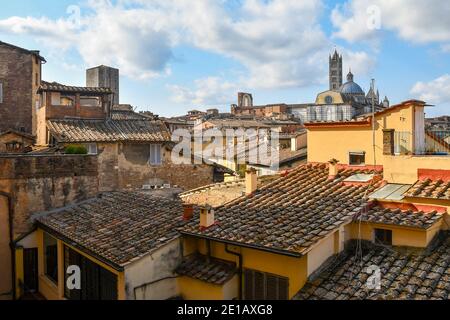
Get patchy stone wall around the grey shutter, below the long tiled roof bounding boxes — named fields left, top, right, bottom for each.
left=92, top=143, right=214, bottom=191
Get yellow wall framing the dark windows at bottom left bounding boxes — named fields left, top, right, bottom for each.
left=36, top=229, right=125, bottom=300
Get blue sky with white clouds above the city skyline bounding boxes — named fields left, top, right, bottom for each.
left=0, top=0, right=450, bottom=116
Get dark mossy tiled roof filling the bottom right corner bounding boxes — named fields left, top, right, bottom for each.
left=294, top=234, right=450, bottom=300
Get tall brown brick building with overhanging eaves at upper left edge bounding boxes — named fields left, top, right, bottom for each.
left=0, top=41, right=46, bottom=135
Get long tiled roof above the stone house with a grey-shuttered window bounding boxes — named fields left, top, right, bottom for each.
left=47, top=119, right=170, bottom=143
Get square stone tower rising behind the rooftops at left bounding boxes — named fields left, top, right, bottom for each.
left=86, top=65, right=120, bottom=105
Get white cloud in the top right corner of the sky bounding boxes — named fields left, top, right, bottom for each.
left=331, top=0, right=450, bottom=43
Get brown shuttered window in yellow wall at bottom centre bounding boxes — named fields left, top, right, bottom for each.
left=244, top=269, right=289, bottom=300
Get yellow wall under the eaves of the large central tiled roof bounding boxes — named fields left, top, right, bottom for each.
left=184, top=237, right=307, bottom=298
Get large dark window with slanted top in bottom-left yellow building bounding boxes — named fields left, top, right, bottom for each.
left=64, top=246, right=117, bottom=300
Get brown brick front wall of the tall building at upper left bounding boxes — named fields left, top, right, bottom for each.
left=0, top=44, right=33, bottom=134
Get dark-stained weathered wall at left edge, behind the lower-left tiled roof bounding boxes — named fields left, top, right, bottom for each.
left=0, top=155, right=98, bottom=236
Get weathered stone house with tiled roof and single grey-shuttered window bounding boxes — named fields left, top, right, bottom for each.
left=47, top=119, right=223, bottom=191
